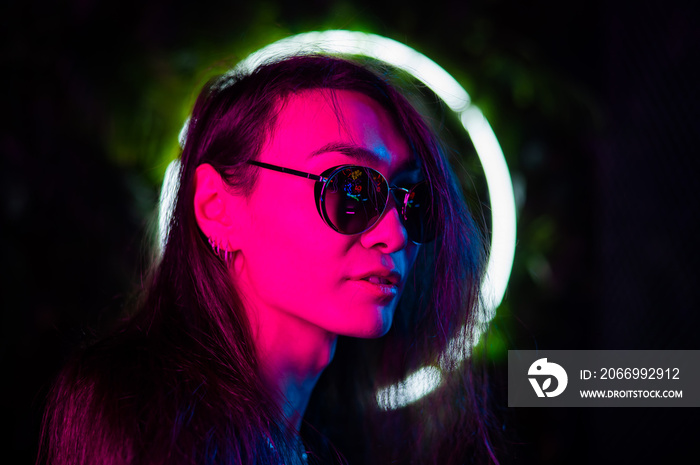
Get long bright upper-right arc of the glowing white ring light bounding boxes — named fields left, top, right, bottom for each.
left=236, top=30, right=516, bottom=321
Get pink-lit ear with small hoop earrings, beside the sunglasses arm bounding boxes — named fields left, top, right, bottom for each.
left=194, top=163, right=245, bottom=251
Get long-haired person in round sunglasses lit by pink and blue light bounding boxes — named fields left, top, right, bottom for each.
left=40, top=56, right=495, bottom=464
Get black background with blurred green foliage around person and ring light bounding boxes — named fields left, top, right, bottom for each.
left=0, top=0, right=700, bottom=464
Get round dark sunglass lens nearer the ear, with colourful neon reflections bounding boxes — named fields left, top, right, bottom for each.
left=323, top=166, right=388, bottom=234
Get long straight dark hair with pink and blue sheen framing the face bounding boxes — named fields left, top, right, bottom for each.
left=38, top=55, right=495, bottom=464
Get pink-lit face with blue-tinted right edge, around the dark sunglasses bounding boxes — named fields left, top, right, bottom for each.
left=234, top=91, right=421, bottom=337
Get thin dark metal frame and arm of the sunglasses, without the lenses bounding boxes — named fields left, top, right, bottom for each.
left=247, top=160, right=426, bottom=244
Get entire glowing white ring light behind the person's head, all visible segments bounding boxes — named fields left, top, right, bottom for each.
left=160, top=30, right=516, bottom=409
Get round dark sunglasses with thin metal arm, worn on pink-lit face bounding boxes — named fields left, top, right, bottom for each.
left=248, top=160, right=435, bottom=244
